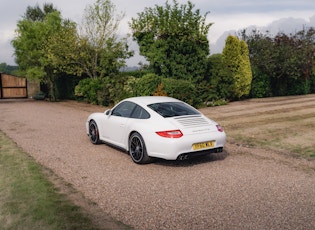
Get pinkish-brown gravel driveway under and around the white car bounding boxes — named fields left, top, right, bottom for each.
left=0, top=100, right=315, bottom=229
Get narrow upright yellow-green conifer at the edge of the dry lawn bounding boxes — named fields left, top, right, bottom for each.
left=222, top=35, right=252, bottom=99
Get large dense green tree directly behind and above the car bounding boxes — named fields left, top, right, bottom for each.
left=129, top=0, right=212, bottom=80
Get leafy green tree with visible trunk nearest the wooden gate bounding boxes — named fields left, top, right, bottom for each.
left=12, top=4, right=77, bottom=100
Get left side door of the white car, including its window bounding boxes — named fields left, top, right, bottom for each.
left=102, top=101, right=136, bottom=149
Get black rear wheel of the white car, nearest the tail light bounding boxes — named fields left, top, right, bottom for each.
left=129, top=133, right=152, bottom=164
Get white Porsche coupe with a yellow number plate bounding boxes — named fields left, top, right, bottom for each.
left=86, top=96, right=226, bottom=164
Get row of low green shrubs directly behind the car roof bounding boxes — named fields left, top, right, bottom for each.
left=75, top=73, right=201, bottom=106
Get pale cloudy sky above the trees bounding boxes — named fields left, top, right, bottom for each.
left=0, top=0, right=315, bottom=66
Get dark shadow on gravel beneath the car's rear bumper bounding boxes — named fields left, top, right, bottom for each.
left=153, top=150, right=229, bottom=167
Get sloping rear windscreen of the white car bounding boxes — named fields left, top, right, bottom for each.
left=148, top=102, right=200, bottom=117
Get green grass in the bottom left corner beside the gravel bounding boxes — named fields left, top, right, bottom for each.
left=0, top=131, right=96, bottom=230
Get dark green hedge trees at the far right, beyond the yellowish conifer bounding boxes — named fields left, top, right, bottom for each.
left=243, top=28, right=315, bottom=96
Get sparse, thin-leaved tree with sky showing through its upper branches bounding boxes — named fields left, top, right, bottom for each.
left=79, top=0, right=132, bottom=78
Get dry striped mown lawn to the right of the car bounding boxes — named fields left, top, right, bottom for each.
left=201, top=95, right=315, bottom=160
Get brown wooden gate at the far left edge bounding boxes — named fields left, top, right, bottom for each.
left=0, top=73, right=27, bottom=99
